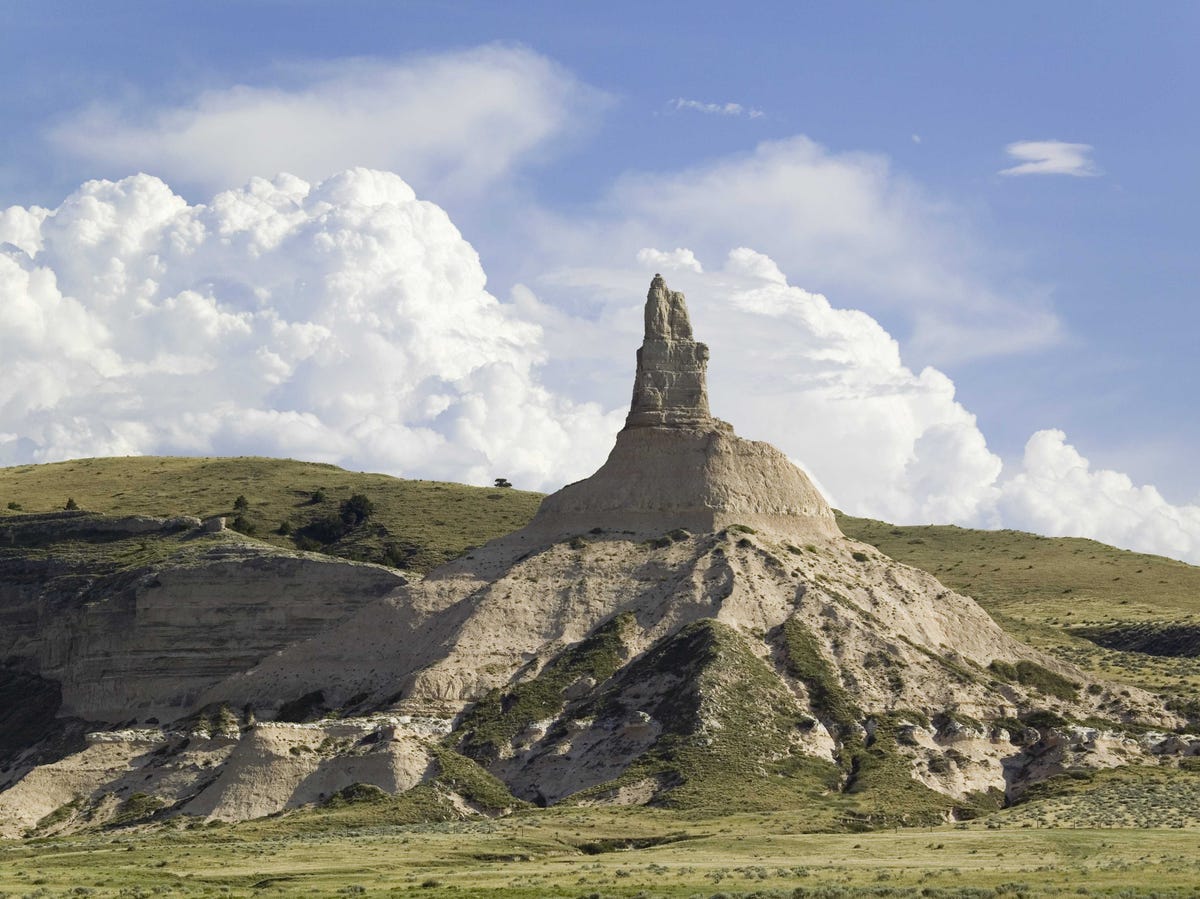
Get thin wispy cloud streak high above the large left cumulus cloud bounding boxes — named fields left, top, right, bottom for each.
left=49, top=46, right=607, bottom=193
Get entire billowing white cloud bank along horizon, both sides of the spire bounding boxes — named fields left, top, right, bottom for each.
left=0, top=169, right=1200, bottom=562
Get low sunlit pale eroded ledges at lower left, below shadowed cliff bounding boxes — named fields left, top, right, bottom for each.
left=0, top=715, right=450, bottom=839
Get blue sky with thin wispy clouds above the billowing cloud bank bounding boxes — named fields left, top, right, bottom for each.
left=0, top=0, right=1200, bottom=555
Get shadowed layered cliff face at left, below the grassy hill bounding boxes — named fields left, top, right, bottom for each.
left=0, top=515, right=406, bottom=724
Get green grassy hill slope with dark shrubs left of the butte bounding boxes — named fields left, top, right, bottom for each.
left=0, top=456, right=541, bottom=573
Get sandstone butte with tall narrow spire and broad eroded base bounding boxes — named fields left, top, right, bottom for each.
left=0, top=276, right=1180, bottom=835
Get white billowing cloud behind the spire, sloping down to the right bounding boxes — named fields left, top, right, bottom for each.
left=522, top=247, right=1200, bottom=563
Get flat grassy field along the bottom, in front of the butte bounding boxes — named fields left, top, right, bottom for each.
left=0, top=809, right=1200, bottom=898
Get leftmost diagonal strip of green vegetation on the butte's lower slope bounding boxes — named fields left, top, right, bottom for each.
left=455, top=612, right=634, bottom=765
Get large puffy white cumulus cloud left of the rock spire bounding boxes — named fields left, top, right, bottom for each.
left=0, top=169, right=620, bottom=487
